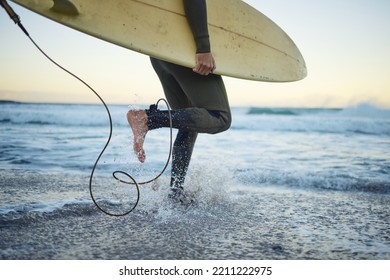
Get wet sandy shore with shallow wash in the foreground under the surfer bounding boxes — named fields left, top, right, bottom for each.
left=0, top=170, right=390, bottom=260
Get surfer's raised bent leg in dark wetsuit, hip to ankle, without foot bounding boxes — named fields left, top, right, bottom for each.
left=148, top=58, right=231, bottom=134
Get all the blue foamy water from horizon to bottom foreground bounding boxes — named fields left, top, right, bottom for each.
left=0, top=102, right=390, bottom=259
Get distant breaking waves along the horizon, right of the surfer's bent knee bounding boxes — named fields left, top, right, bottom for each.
left=232, top=104, right=390, bottom=135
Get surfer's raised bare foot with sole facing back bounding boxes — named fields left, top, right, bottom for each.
left=127, top=110, right=148, bottom=163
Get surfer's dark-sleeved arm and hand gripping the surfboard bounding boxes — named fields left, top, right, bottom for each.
left=183, top=0, right=216, bottom=75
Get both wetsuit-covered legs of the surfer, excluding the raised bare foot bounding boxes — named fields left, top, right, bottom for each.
left=147, top=58, right=231, bottom=201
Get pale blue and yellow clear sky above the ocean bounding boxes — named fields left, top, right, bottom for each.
left=0, top=0, right=390, bottom=108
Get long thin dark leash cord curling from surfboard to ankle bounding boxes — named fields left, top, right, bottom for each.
left=0, top=0, right=173, bottom=217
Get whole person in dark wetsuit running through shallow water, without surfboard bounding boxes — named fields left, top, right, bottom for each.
left=127, top=0, right=231, bottom=203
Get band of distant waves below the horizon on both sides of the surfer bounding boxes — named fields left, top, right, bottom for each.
left=0, top=103, right=390, bottom=134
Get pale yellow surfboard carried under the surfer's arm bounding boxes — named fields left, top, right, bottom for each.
left=11, top=0, right=307, bottom=82
